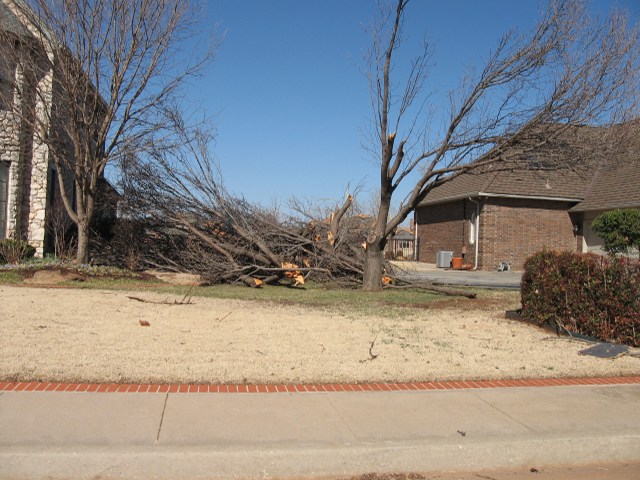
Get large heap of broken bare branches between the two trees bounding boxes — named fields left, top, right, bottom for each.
left=115, top=125, right=370, bottom=287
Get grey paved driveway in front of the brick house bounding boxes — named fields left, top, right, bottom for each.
left=392, top=262, right=522, bottom=290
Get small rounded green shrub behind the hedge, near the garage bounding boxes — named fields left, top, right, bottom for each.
left=591, top=208, right=640, bottom=255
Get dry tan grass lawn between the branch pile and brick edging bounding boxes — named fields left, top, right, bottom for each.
left=0, top=285, right=640, bottom=383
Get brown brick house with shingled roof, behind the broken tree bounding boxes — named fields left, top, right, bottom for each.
left=415, top=127, right=640, bottom=270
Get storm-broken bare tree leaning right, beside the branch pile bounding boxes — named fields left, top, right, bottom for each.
left=364, top=0, right=640, bottom=290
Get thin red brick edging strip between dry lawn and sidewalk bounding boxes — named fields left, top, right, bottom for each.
left=0, top=377, right=640, bottom=393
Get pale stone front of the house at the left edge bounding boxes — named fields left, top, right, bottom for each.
left=0, top=0, right=73, bottom=256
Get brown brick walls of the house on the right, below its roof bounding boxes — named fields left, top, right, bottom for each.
left=416, top=198, right=580, bottom=270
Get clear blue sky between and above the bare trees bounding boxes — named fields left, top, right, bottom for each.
left=188, top=0, right=640, bottom=209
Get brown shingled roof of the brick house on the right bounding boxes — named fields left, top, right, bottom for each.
left=420, top=122, right=640, bottom=211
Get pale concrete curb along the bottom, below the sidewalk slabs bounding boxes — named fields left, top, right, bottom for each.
left=5, top=434, right=640, bottom=480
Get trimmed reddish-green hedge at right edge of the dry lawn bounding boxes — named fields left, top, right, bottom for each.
left=521, top=251, right=640, bottom=347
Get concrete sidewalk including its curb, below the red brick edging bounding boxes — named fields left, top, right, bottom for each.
left=0, top=384, right=640, bottom=479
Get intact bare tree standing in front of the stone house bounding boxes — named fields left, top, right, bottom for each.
left=0, top=0, right=213, bottom=263
